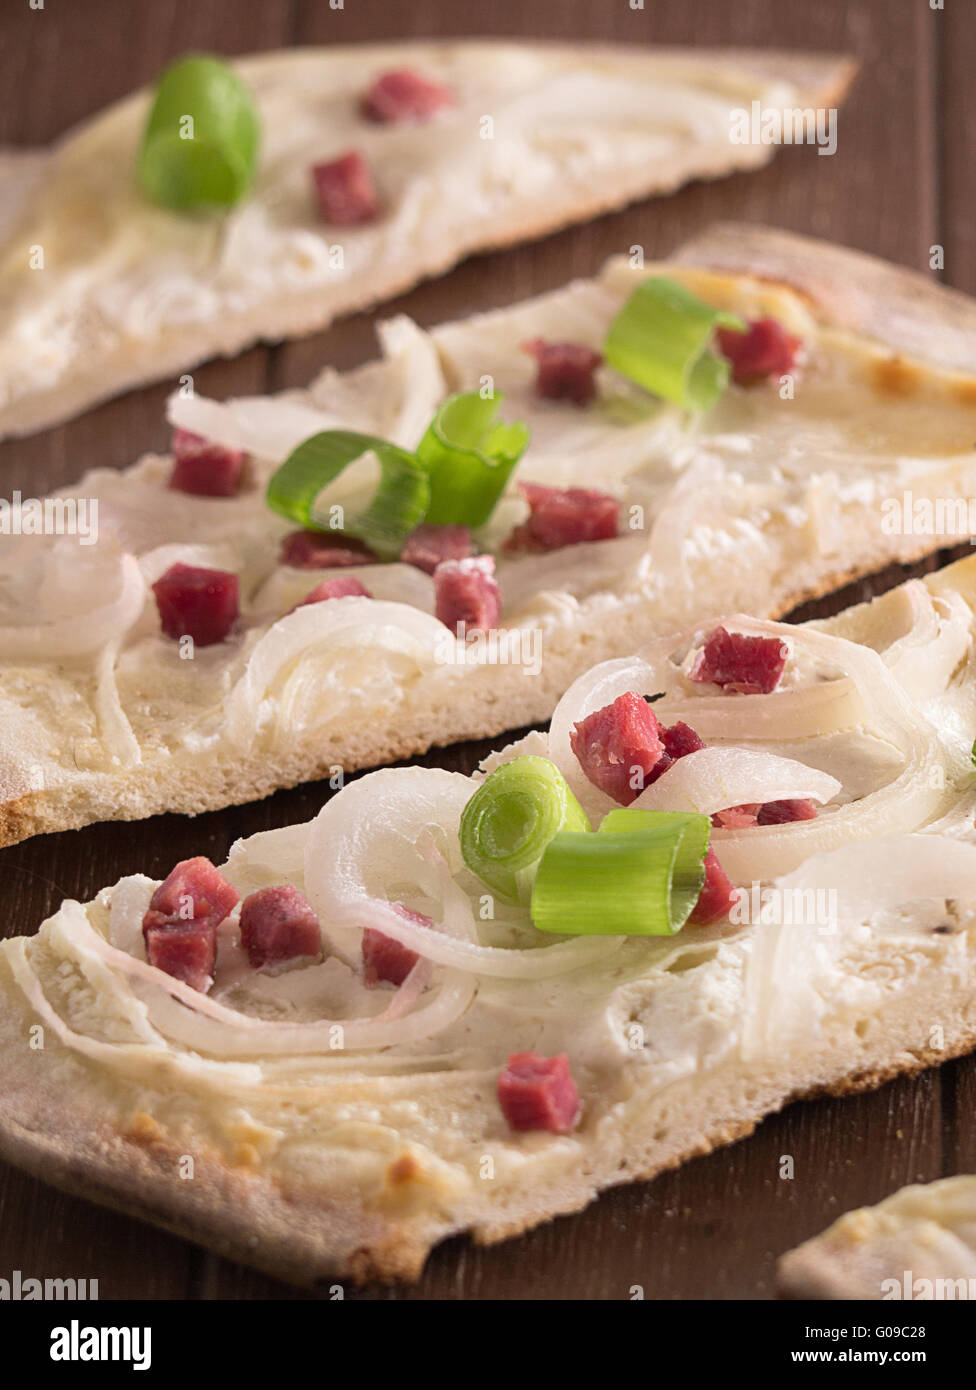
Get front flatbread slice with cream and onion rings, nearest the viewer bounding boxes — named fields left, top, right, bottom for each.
left=0, top=559, right=976, bottom=1284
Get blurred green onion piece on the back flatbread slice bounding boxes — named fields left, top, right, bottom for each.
left=138, top=56, right=260, bottom=210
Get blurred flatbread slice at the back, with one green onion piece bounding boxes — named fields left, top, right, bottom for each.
left=0, top=40, right=855, bottom=436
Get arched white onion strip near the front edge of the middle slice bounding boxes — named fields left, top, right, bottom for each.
left=225, top=598, right=446, bottom=748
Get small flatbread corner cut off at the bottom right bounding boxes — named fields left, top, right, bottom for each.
left=777, top=1176, right=976, bottom=1301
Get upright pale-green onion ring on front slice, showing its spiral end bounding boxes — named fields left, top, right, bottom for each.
left=460, top=756, right=592, bottom=902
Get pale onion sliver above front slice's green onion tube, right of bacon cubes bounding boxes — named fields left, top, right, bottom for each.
left=634, top=745, right=841, bottom=816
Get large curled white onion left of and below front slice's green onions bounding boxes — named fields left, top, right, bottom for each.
left=304, top=767, right=620, bottom=980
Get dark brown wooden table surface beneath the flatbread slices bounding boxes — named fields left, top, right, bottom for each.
left=0, top=0, right=976, bottom=1298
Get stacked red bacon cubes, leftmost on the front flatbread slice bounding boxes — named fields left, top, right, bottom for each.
left=142, top=855, right=239, bottom=994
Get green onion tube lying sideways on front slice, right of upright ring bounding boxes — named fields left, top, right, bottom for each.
left=531, top=808, right=710, bottom=937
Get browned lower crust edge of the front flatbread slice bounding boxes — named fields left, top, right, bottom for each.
left=0, top=1000, right=976, bottom=1287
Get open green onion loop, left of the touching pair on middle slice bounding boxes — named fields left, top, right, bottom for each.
left=267, top=430, right=430, bottom=559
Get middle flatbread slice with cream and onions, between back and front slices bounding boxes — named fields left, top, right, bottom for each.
left=0, top=228, right=976, bottom=844
